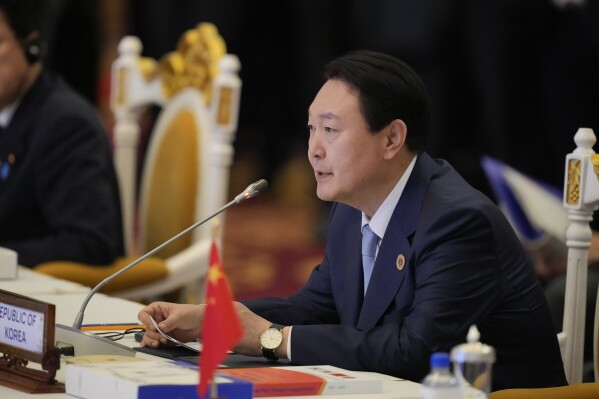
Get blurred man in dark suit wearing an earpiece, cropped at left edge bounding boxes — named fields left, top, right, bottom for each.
left=0, top=0, right=123, bottom=267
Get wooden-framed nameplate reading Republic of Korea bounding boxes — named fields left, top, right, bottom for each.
left=0, top=290, right=64, bottom=393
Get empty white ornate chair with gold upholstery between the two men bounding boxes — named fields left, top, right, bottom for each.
left=37, top=23, right=241, bottom=301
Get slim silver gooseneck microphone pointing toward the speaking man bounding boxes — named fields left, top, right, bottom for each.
left=56, top=179, right=268, bottom=356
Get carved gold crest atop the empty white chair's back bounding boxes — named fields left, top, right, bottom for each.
left=159, top=22, right=227, bottom=104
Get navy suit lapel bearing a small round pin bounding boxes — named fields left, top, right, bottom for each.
left=357, top=153, right=434, bottom=330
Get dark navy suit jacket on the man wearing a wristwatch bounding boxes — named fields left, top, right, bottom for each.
left=244, top=153, right=566, bottom=390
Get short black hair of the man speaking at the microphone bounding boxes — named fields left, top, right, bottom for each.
left=324, top=50, right=430, bottom=152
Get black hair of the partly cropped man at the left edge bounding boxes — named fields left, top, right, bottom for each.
left=0, top=0, right=48, bottom=40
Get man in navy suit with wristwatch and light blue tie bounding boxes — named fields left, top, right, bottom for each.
left=139, top=51, right=566, bottom=389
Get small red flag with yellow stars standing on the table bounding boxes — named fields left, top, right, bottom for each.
left=198, top=242, right=243, bottom=398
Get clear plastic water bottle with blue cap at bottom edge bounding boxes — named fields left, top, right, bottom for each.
left=420, top=352, right=462, bottom=399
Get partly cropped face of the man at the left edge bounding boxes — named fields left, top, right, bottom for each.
left=0, top=11, right=29, bottom=109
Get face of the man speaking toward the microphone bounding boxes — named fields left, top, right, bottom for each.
left=308, top=80, right=386, bottom=211
